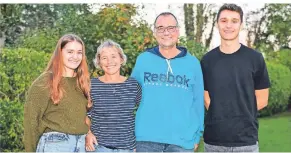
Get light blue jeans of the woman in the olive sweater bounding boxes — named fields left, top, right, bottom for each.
left=36, top=132, right=86, bottom=152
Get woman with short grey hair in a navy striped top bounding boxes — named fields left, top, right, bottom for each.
left=86, top=40, right=141, bottom=152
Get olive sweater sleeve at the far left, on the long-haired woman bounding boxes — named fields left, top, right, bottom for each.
left=24, top=74, right=49, bottom=152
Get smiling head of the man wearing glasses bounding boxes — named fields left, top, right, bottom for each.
left=154, top=15, right=180, bottom=48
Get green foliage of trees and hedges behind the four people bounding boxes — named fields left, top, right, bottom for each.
left=0, top=4, right=291, bottom=152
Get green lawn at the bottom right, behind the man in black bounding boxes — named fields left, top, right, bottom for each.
left=198, top=111, right=291, bottom=152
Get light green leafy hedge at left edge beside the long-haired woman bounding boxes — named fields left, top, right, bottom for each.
left=0, top=48, right=50, bottom=152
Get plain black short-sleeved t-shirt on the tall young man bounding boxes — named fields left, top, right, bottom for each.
left=201, top=45, right=270, bottom=147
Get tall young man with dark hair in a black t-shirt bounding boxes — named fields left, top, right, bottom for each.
left=201, top=4, right=270, bottom=152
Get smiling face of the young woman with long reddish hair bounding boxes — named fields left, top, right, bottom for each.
left=62, top=41, right=83, bottom=74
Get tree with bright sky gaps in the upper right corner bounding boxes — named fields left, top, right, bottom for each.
left=246, top=4, right=291, bottom=52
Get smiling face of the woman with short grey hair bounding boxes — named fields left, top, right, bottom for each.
left=99, top=47, right=124, bottom=75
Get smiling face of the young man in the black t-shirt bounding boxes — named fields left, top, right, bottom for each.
left=217, top=10, right=242, bottom=41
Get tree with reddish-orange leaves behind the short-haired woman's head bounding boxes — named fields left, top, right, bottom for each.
left=64, top=4, right=154, bottom=75
